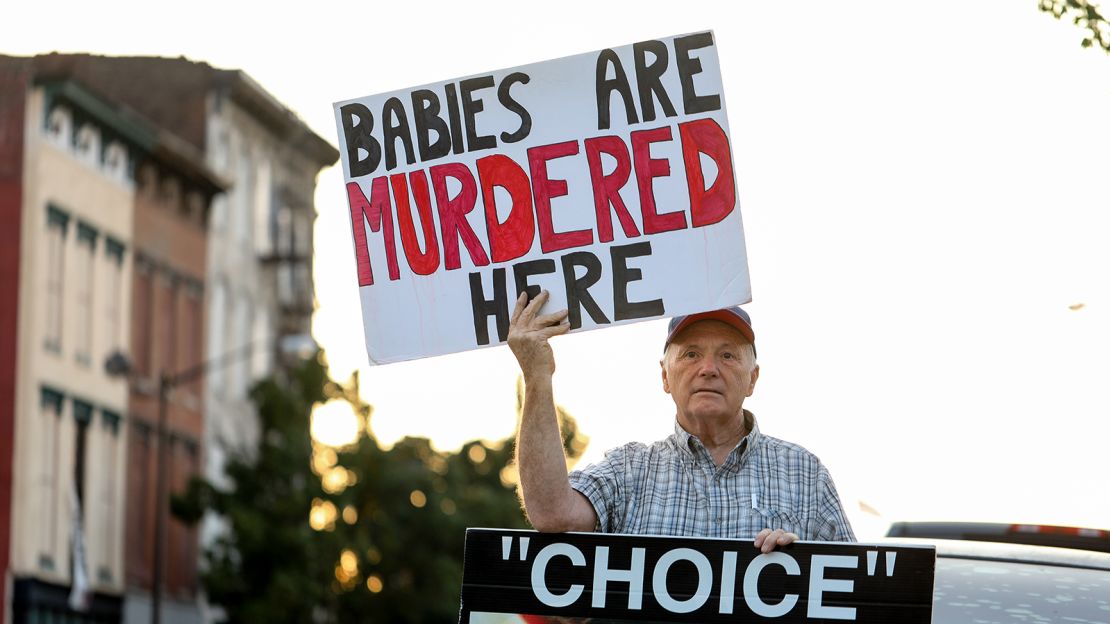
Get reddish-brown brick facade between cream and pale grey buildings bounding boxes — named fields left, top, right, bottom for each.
left=124, top=132, right=222, bottom=622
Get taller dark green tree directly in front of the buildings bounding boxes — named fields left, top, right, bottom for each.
left=172, top=359, right=339, bottom=622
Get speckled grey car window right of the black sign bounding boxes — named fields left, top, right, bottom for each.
left=932, top=557, right=1110, bottom=624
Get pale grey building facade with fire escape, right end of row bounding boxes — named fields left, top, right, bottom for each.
left=205, top=73, right=339, bottom=495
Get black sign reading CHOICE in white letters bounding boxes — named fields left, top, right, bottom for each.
left=460, top=529, right=936, bottom=624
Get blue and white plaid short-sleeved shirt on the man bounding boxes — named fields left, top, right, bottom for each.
left=571, top=410, right=856, bottom=542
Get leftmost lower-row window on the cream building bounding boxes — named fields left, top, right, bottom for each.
left=37, top=386, right=64, bottom=570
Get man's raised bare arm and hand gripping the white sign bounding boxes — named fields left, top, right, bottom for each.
left=508, top=291, right=597, bottom=532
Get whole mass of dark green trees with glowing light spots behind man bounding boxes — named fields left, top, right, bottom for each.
left=173, top=356, right=585, bottom=623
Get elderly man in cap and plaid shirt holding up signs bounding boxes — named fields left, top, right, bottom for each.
left=508, top=292, right=855, bottom=553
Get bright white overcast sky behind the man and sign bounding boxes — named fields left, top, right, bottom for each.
left=0, top=0, right=1110, bottom=535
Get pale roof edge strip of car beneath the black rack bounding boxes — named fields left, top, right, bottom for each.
left=881, top=537, right=1110, bottom=572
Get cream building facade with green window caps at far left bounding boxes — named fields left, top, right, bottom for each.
left=0, top=59, right=138, bottom=622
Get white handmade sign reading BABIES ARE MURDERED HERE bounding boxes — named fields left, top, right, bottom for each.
left=335, top=32, right=751, bottom=363
